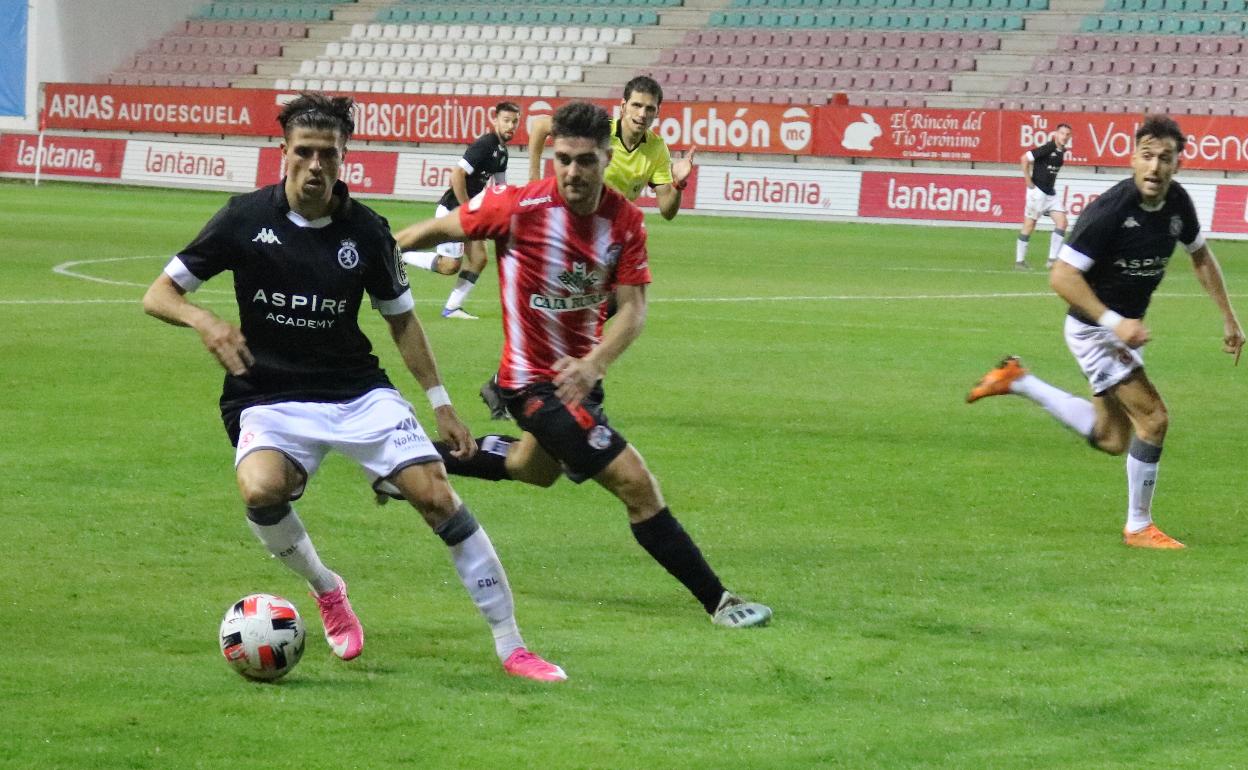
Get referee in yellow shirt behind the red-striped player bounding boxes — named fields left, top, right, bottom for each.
left=529, top=75, right=698, bottom=220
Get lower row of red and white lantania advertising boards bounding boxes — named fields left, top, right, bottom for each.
left=0, top=134, right=1248, bottom=238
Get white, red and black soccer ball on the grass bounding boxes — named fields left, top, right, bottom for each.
left=221, top=594, right=305, bottom=681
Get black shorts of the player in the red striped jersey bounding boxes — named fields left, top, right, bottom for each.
left=503, top=382, right=628, bottom=484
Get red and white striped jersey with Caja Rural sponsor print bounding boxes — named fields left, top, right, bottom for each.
left=459, top=177, right=650, bottom=388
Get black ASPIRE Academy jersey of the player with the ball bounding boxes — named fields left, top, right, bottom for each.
left=168, top=180, right=411, bottom=443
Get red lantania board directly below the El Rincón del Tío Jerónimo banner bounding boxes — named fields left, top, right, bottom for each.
left=859, top=171, right=1027, bottom=223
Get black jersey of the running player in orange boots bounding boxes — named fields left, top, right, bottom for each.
left=1063, top=180, right=1204, bottom=323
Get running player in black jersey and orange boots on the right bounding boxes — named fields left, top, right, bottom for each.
left=967, top=116, right=1244, bottom=548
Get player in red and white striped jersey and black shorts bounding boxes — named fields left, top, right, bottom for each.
left=397, top=102, right=771, bottom=628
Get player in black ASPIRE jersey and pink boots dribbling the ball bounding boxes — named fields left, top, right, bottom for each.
left=144, top=94, right=567, bottom=681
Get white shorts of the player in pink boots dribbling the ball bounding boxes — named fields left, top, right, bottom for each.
left=235, top=388, right=441, bottom=500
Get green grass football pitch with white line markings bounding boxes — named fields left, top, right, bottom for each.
left=0, top=183, right=1248, bottom=770
